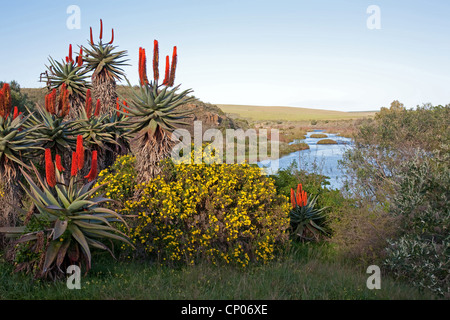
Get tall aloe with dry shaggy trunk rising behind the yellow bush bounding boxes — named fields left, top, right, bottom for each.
left=124, top=40, right=193, bottom=183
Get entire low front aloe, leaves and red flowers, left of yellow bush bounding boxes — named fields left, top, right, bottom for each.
left=0, top=149, right=131, bottom=279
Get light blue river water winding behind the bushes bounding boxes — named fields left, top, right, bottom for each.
left=258, top=130, right=353, bottom=189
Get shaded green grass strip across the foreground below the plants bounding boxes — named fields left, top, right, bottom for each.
left=0, top=245, right=434, bottom=300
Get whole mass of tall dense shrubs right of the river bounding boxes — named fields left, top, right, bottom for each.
left=340, top=102, right=450, bottom=297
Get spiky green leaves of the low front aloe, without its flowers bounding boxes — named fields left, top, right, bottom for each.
left=0, top=165, right=132, bottom=277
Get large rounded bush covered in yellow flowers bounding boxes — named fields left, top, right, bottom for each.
left=99, top=154, right=290, bottom=267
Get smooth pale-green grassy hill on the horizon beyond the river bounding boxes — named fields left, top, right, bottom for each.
left=217, top=104, right=375, bottom=121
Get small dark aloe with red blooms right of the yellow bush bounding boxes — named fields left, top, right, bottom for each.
left=289, top=183, right=328, bottom=241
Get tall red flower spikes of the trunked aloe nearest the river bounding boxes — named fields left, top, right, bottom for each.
left=139, top=40, right=177, bottom=87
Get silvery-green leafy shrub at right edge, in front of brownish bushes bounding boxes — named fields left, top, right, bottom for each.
left=385, top=152, right=450, bottom=296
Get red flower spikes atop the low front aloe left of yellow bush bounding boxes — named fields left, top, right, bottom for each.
left=45, top=135, right=98, bottom=188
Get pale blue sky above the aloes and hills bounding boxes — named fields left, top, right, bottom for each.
left=0, top=0, right=450, bottom=111
